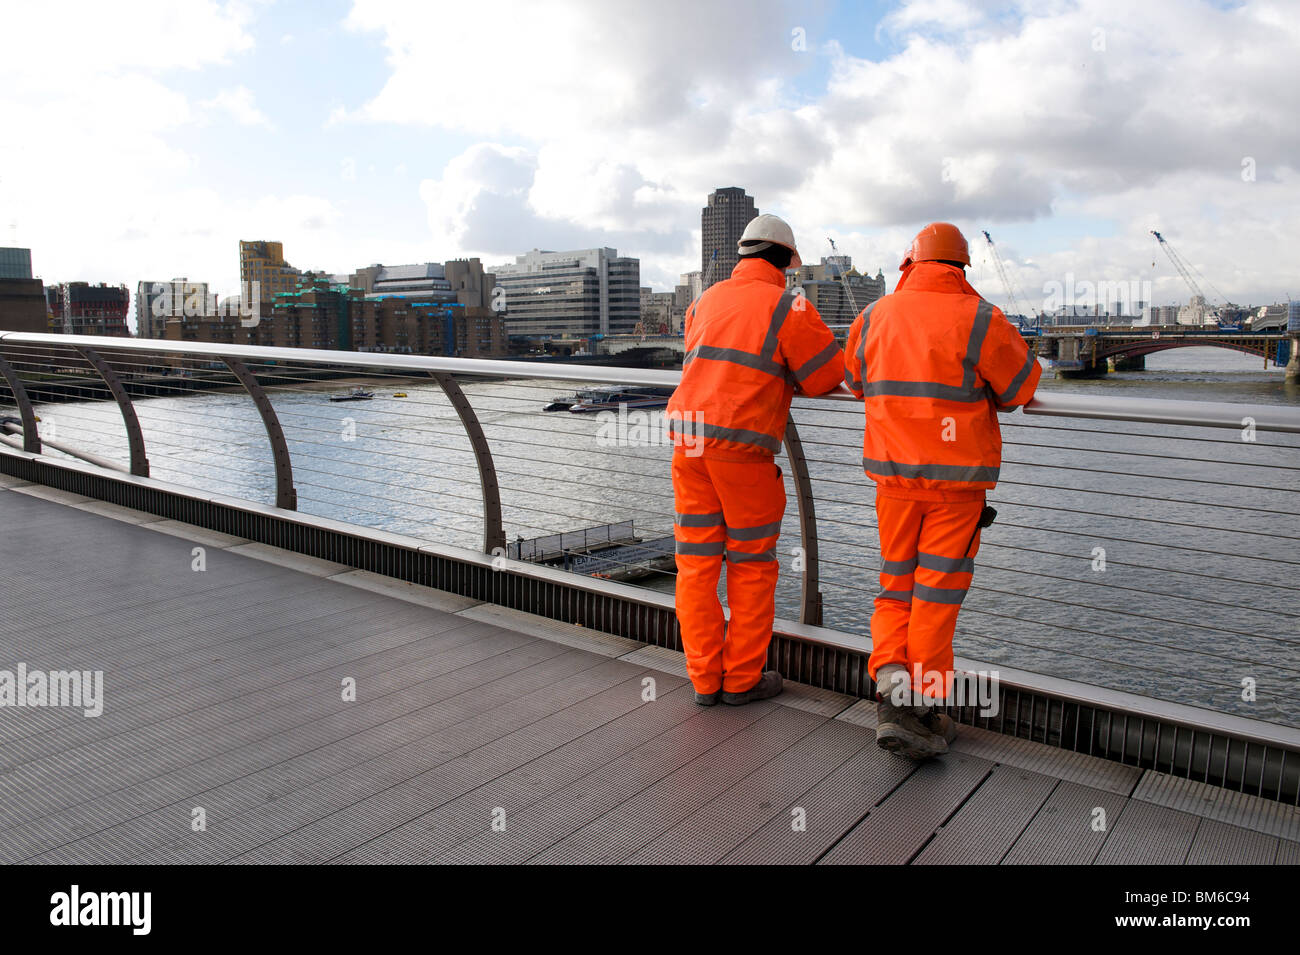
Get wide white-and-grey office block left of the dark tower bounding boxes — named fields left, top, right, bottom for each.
left=490, top=248, right=641, bottom=339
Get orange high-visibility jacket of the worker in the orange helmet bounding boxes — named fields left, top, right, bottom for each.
left=844, top=261, right=1041, bottom=496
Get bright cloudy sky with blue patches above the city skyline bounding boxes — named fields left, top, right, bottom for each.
left=0, top=0, right=1300, bottom=324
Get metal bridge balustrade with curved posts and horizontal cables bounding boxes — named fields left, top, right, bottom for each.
left=0, top=333, right=1300, bottom=802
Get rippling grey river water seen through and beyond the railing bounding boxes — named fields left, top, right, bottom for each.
left=20, top=348, right=1300, bottom=726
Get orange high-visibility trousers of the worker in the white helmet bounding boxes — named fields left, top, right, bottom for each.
left=672, top=452, right=785, bottom=694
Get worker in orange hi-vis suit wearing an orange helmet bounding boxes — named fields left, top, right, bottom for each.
left=844, top=222, right=1041, bottom=759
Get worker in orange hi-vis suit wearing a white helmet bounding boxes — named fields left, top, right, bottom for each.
left=666, top=216, right=844, bottom=706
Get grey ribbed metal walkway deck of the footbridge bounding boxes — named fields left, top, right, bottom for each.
left=0, top=477, right=1300, bottom=864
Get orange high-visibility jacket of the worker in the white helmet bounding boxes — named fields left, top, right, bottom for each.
left=666, top=259, right=844, bottom=460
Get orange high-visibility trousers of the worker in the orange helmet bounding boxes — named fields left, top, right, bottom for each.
left=867, top=487, right=984, bottom=699
